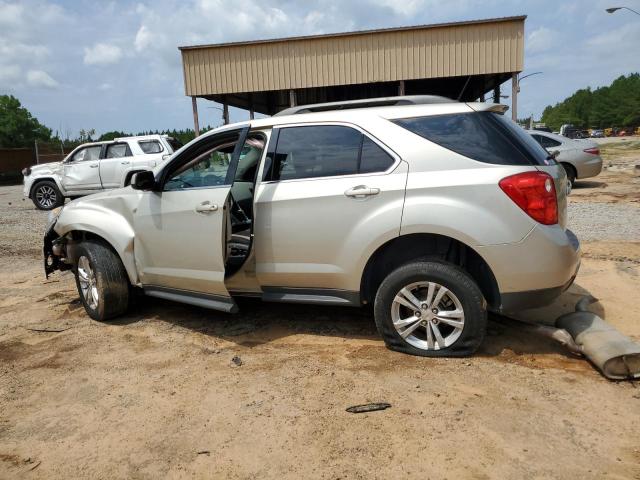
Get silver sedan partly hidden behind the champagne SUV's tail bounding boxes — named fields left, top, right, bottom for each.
left=529, top=130, right=602, bottom=193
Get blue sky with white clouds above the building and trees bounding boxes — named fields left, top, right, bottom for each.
left=0, top=0, right=640, bottom=138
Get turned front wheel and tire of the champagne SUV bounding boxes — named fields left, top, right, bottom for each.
left=74, top=240, right=129, bottom=321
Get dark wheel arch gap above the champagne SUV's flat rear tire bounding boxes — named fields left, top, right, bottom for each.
left=360, top=233, right=501, bottom=308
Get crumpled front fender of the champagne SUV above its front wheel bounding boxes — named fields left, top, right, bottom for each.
left=54, top=194, right=140, bottom=285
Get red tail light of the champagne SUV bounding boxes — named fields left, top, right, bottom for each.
left=499, top=172, right=558, bottom=225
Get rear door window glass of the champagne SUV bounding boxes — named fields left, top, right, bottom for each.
left=265, top=125, right=394, bottom=180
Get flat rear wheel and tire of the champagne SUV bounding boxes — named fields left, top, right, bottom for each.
left=374, top=262, right=487, bottom=357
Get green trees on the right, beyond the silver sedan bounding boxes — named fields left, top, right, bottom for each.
left=542, top=73, right=640, bottom=130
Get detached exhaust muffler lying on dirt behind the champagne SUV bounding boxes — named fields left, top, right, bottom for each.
left=503, top=296, right=640, bottom=380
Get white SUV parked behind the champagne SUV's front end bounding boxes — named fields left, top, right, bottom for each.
left=22, top=135, right=180, bottom=210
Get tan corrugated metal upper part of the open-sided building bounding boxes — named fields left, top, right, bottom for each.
left=180, top=16, right=526, bottom=105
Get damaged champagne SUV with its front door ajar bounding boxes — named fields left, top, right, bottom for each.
left=44, top=97, right=580, bottom=356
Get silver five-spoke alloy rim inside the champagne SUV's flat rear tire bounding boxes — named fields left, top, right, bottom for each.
left=391, top=281, right=464, bottom=350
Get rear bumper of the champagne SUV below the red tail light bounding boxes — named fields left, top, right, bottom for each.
left=478, top=225, right=581, bottom=312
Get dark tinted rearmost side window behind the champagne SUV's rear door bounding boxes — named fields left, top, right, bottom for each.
left=393, top=112, right=553, bottom=165
